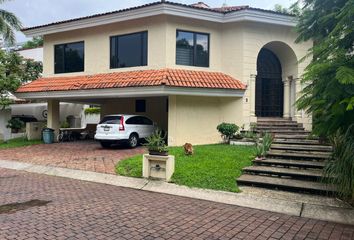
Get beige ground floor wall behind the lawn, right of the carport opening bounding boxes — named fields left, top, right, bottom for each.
left=168, top=96, right=242, bottom=146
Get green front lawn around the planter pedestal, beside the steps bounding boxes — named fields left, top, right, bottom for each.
left=116, top=145, right=255, bottom=192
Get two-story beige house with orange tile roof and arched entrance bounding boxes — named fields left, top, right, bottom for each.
left=16, top=1, right=312, bottom=145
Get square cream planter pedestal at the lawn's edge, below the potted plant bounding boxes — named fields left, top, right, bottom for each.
left=143, top=154, right=175, bottom=182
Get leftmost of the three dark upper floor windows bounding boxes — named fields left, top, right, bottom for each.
left=54, top=42, right=85, bottom=73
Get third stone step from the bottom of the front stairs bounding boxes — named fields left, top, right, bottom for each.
left=252, top=158, right=325, bottom=169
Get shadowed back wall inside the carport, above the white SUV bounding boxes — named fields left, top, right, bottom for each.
left=101, top=97, right=168, bottom=131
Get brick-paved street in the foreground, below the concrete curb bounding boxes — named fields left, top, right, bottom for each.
left=0, top=169, right=354, bottom=240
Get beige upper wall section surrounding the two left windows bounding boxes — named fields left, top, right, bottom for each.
left=43, top=16, right=166, bottom=76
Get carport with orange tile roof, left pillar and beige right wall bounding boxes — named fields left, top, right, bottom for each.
left=16, top=69, right=246, bottom=146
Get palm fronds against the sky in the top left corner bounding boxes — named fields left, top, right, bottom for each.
left=0, top=0, right=22, bottom=44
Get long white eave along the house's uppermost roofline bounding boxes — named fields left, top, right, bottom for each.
left=22, top=3, right=296, bottom=37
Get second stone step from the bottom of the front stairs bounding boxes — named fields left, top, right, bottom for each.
left=242, top=166, right=323, bottom=180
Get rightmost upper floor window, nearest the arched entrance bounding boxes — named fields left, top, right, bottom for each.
left=176, top=30, right=209, bottom=67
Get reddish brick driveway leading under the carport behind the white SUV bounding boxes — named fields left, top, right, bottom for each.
left=0, top=141, right=145, bottom=174
